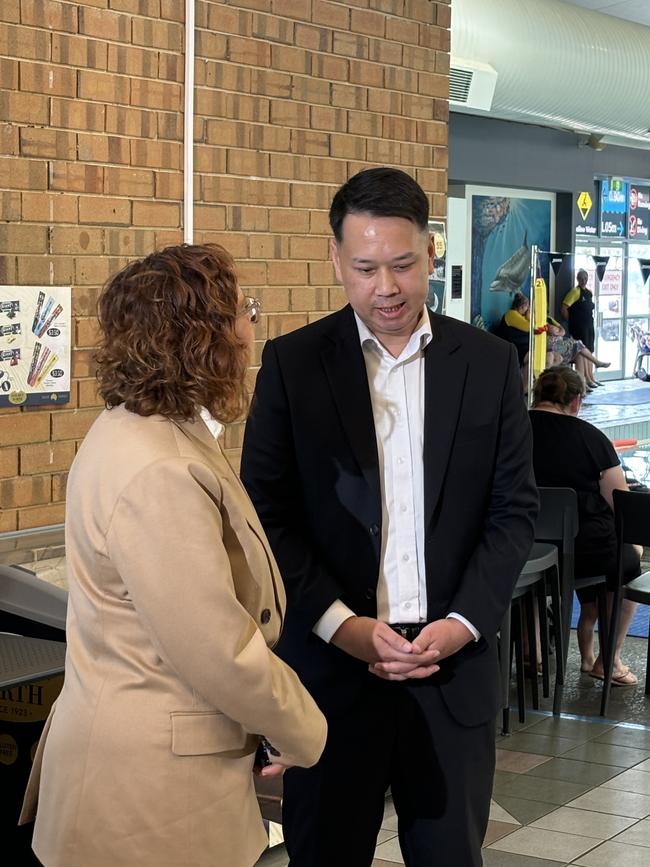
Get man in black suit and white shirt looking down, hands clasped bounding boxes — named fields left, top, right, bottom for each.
left=241, top=168, right=537, bottom=867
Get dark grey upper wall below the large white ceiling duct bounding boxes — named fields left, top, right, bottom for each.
left=449, top=112, right=650, bottom=193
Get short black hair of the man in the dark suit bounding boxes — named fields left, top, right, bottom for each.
left=329, top=166, right=429, bottom=244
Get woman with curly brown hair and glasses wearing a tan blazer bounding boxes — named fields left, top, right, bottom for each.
left=22, top=244, right=326, bottom=867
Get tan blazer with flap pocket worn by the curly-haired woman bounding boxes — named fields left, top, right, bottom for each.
left=21, top=407, right=326, bottom=867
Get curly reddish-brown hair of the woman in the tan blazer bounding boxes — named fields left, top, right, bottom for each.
left=95, top=244, right=249, bottom=422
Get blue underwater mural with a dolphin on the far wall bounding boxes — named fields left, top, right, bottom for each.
left=471, top=195, right=551, bottom=330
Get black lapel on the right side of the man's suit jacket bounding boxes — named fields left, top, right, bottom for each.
left=424, top=313, right=467, bottom=531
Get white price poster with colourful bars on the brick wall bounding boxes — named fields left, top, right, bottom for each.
left=0, top=286, right=71, bottom=407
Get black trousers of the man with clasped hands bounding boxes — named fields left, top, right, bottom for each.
left=282, top=674, right=495, bottom=867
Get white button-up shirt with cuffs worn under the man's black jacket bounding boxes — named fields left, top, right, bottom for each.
left=314, top=308, right=480, bottom=641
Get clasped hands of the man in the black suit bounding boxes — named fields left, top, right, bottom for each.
left=331, top=617, right=473, bottom=680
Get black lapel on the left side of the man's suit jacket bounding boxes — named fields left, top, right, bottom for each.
left=321, top=306, right=381, bottom=501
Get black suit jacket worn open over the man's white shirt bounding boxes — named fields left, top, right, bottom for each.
left=241, top=306, right=537, bottom=725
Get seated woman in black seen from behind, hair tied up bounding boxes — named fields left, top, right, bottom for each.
left=530, top=367, right=643, bottom=686
